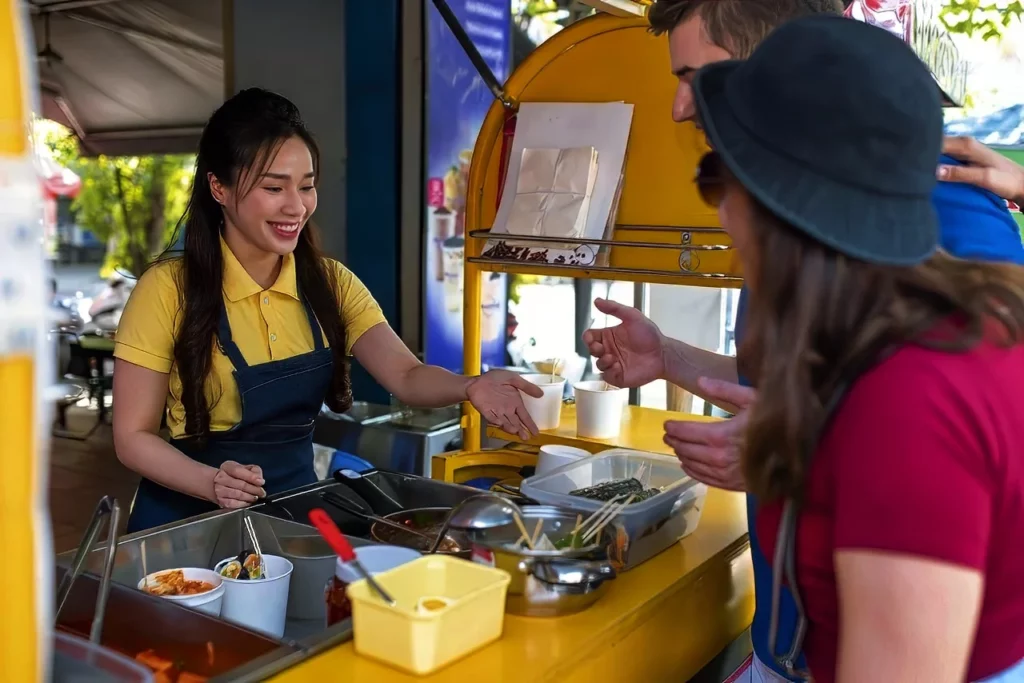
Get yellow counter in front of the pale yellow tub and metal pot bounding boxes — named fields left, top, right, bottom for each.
left=272, top=488, right=754, bottom=683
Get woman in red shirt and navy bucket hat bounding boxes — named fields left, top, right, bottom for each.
left=693, top=16, right=1024, bottom=683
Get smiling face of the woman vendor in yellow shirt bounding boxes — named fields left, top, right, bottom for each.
left=210, top=137, right=316, bottom=256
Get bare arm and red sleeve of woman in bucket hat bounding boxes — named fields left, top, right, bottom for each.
left=823, top=353, right=994, bottom=683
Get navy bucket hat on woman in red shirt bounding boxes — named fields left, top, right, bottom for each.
left=693, top=15, right=943, bottom=265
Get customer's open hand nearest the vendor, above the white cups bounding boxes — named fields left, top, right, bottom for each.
left=583, top=299, right=665, bottom=388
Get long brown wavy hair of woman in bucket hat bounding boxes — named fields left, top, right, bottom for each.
left=738, top=199, right=1024, bottom=501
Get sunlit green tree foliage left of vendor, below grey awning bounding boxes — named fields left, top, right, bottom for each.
left=39, top=120, right=195, bottom=275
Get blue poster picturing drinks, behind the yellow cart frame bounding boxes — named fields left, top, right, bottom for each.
left=423, top=0, right=512, bottom=372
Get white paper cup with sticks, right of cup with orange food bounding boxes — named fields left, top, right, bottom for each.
left=217, top=555, right=294, bottom=638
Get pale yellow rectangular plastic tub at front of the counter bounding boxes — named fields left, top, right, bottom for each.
left=348, top=555, right=510, bottom=675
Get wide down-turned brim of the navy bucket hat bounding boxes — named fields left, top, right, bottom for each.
left=693, top=61, right=938, bottom=265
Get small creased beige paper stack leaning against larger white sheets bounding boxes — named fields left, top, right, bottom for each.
left=506, top=146, right=597, bottom=239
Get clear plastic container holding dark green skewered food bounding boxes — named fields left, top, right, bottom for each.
left=521, top=449, right=708, bottom=571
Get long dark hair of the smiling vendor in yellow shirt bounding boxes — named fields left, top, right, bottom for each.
left=161, top=88, right=352, bottom=440
